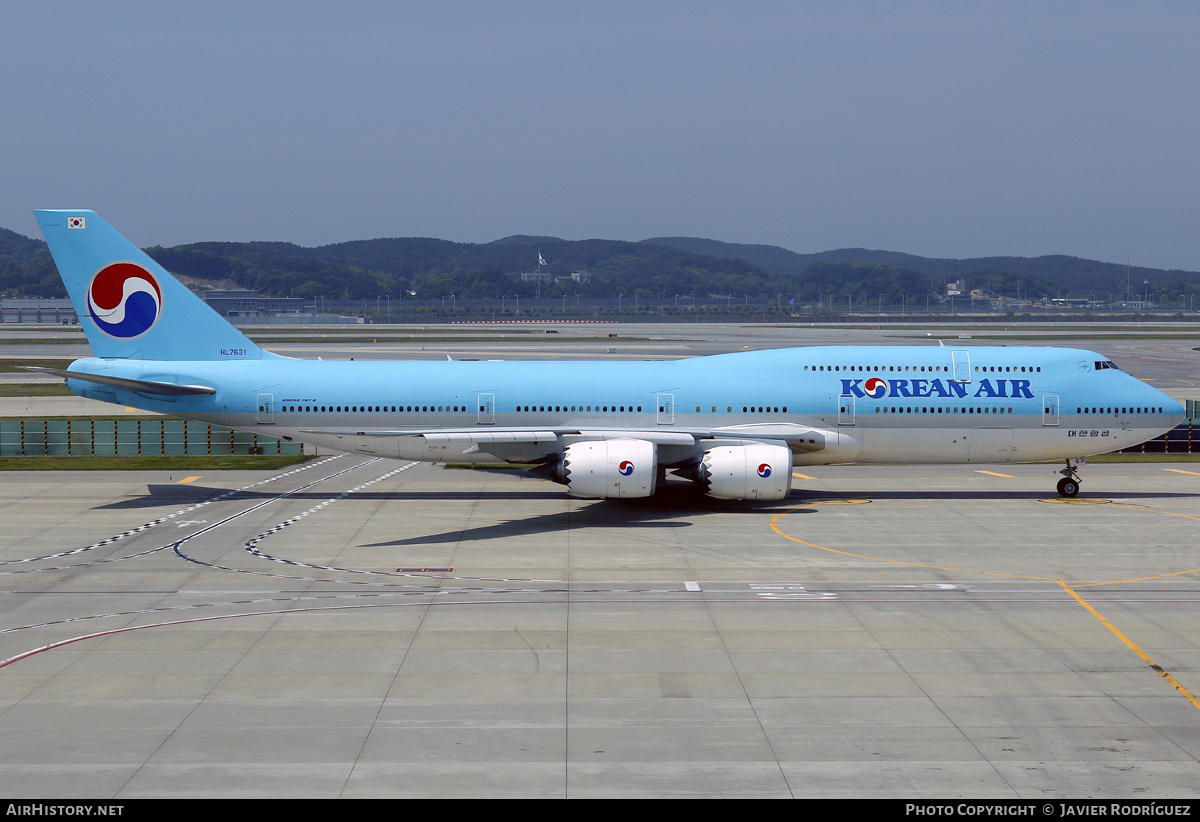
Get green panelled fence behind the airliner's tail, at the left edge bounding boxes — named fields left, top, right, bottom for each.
left=0, top=419, right=302, bottom=457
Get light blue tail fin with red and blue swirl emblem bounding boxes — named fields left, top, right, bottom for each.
left=34, top=210, right=274, bottom=360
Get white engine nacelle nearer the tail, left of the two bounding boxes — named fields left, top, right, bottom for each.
left=556, top=439, right=659, bottom=499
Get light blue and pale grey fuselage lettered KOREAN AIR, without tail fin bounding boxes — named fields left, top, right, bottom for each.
left=68, top=346, right=1183, bottom=464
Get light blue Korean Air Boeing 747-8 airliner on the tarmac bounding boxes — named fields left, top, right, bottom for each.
left=25, top=210, right=1183, bottom=499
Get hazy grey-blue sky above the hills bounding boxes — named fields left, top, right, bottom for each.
left=0, top=0, right=1200, bottom=270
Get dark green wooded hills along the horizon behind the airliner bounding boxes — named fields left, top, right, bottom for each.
left=7, top=223, right=1200, bottom=306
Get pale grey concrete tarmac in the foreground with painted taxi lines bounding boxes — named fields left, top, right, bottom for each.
left=0, top=456, right=1200, bottom=799
